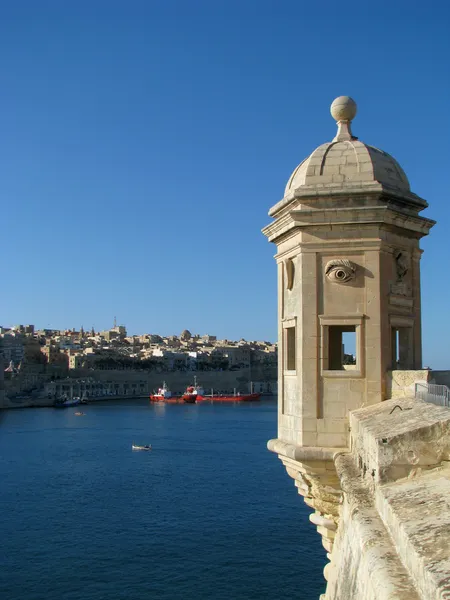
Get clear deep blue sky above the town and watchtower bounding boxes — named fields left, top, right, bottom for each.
left=0, top=0, right=450, bottom=368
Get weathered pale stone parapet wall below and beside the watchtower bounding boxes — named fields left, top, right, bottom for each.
left=322, top=398, right=450, bottom=600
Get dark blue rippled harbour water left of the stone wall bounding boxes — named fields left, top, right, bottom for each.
left=0, top=400, right=325, bottom=600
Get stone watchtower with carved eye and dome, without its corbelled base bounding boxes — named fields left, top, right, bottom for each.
left=263, top=96, right=434, bottom=456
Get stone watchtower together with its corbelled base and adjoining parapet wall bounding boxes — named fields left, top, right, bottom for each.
left=263, top=96, right=450, bottom=600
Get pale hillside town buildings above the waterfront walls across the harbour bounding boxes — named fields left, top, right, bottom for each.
left=0, top=320, right=277, bottom=375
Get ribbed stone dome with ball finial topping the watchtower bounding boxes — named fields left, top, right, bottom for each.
left=284, top=96, right=410, bottom=197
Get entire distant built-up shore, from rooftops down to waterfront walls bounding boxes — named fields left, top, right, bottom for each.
left=0, top=322, right=278, bottom=408
